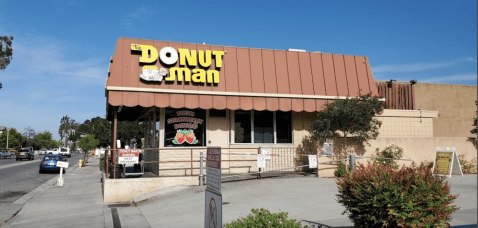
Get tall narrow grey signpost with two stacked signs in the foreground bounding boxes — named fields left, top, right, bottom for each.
left=204, top=147, right=222, bottom=228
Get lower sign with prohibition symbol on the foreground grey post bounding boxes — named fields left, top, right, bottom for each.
left=204, top=189, right=222, bottom=228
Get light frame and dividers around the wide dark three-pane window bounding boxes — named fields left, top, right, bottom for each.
left=229, top=110, right=294, bottom=146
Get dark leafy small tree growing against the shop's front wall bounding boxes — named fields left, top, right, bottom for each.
left=312, top=95, right=385, bottom=155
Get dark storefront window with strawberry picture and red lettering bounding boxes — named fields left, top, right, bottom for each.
left=164, top=109, right=206, bottom=147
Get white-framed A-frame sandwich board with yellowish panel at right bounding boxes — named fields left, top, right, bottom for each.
left=433, top=147, right=463, bottom=178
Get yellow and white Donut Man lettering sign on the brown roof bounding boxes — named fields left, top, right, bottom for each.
left=131, top=44, right=225, bottom=84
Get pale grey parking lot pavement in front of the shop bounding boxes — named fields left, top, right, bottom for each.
left=135, top=175, right=477, bottom=227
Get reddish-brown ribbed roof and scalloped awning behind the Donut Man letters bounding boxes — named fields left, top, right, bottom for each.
left=106, top=38, right=378, bottom=116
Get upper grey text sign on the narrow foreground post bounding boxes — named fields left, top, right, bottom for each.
left=206, top=147, right=221, bottom=194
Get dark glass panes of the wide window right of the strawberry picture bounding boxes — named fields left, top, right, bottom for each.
left=234, top=111, right=292, bottom=143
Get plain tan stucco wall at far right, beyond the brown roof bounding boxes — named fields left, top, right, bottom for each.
left=414, top=83, right=477, bottom=137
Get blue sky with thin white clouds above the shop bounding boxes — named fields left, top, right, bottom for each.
left=0, top=0, right=477, bottom=139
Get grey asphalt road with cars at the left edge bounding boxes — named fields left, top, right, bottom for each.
left=0, top=154, right=83, bottom=206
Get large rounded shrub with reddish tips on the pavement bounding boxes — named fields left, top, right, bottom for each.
left=337, top=163, right=458, bottom=227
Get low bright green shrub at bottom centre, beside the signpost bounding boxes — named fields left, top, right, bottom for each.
left=225, top=208, right=307, bottom=228
